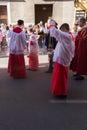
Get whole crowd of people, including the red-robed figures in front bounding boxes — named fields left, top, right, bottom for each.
left=0, top=17, right=87, bottom=98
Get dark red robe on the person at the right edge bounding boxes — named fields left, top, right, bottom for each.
left=70, top=27, right=87, bottom=75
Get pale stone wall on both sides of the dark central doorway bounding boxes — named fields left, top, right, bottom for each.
left=10, top=0, right=74, bottom=26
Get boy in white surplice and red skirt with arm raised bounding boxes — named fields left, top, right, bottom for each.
left=48, top=20, right=75, bottom=97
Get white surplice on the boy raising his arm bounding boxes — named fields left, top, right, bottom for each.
left=50, top=27, right=75, bottom=66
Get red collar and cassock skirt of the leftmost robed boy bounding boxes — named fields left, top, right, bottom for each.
left=8, top=27, right=26, bottom=78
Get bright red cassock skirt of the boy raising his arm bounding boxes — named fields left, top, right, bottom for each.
left=51, top=62, right=68, bottom=95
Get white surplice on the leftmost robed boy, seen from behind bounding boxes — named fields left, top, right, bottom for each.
left=9, top=30, right=26, bottom=54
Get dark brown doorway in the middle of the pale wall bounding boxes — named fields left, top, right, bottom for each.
left=35, top=4, right=53, bottom=24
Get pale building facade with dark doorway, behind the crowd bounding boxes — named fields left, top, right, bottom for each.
left=0, top=0, right=86, bottom=26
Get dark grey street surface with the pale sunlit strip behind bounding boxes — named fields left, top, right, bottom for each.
left=0, top=52, right=87, bottom=130
